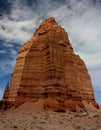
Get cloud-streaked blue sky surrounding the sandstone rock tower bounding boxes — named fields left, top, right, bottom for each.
left=0, top=0, right=101, bottom=104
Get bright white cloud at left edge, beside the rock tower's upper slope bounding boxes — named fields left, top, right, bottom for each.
left=0, top=16, right=36, bottom=44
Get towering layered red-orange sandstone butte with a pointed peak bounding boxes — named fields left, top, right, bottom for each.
left=0, top=17, right=97, bottom=111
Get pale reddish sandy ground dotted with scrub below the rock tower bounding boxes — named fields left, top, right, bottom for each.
left=0, top=103, right=101, bottom=130
